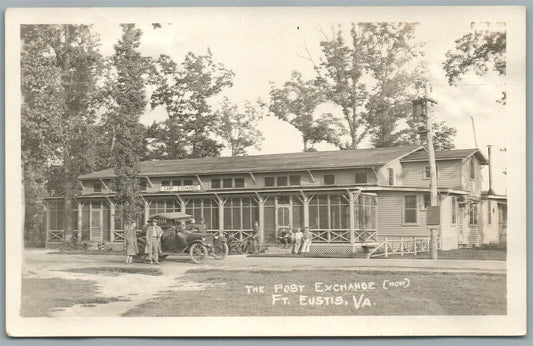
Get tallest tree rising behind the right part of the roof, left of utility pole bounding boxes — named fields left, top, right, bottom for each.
left=315, top=23, right=432, bottom=148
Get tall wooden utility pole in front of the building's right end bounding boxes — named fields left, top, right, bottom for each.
left=413, top=83, right=440, bottom=259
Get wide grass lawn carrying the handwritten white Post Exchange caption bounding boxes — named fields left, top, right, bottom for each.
left=124, top=269, right=506, bottom=316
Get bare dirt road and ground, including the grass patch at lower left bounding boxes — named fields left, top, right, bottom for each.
left=21, top=249, right=506, bottom=317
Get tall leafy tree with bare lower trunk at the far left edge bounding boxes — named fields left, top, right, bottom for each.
left=21, top=25, right=102, bottom=247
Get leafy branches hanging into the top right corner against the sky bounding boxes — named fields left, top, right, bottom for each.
left=443, top=22, right=507, bottom=104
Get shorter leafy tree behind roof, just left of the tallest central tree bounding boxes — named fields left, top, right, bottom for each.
left=263, top=71, right=343, bottom=151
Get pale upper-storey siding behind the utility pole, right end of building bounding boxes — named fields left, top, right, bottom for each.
left=402, top=160, right=462, bottom=189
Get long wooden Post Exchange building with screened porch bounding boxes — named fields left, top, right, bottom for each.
left=46, top=146, right=506, bottom=252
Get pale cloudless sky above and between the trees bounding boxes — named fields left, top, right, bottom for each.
left=89, top=8, right=508, bottom=192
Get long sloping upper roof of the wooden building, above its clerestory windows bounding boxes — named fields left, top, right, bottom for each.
left=80, top=146, right=423, bottom=180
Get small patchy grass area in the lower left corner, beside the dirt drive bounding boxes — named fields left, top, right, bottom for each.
left=20, top=278, right=124, bottom=317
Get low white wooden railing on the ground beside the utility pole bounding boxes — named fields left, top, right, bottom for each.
left=366, top=236, right=430, bottom=258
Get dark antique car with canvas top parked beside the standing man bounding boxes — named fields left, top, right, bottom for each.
left=134, top=212, right=228, bottom=263
